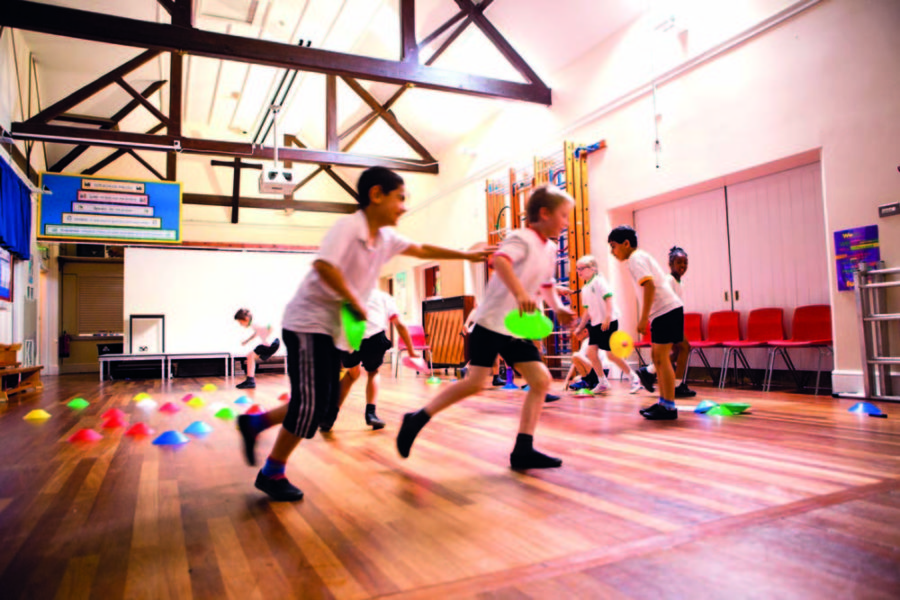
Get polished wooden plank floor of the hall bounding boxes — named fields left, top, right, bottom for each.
left=0, top=374, right=900, bottom=600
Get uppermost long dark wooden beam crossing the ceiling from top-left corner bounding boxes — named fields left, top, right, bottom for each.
left=0, top=0, right=551, bottom=104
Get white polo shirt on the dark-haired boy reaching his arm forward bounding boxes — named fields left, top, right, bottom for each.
left=281, top=210, right=410, bottom=350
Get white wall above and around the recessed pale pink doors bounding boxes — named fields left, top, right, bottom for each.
left=392, top=0, right=900, bottom=391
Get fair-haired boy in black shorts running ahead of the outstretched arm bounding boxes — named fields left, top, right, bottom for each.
left=397, top=185, right=574, bottom=470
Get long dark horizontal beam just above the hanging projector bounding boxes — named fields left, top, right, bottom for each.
left=12, top=122, right=438, bottom=173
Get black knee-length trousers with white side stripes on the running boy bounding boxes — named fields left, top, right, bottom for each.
left=282, top=329, right=341, bottom=439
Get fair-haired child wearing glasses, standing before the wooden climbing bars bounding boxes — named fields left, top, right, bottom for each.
left=575, top=254, right=641, bottom=394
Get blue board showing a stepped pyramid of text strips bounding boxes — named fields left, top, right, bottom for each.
left=37, top=173, right=181, bottom=244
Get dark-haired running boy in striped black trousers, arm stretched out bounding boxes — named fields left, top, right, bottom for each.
left=238, top=167, right=491, bottom=500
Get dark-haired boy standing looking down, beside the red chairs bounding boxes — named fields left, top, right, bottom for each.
left=607, top=225, right=684, bottom=421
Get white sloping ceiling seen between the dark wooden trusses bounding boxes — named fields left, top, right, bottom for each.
left=17, top=0, right=644, bottom=177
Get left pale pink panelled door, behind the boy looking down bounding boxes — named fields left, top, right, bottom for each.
left=634, top=188, right=731, bottom=334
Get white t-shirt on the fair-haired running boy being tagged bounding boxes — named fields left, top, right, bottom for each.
left=475, top=227, right=558, bottom=335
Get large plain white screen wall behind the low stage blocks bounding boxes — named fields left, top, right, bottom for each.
left=123, top=248, right=314, bottom=354
